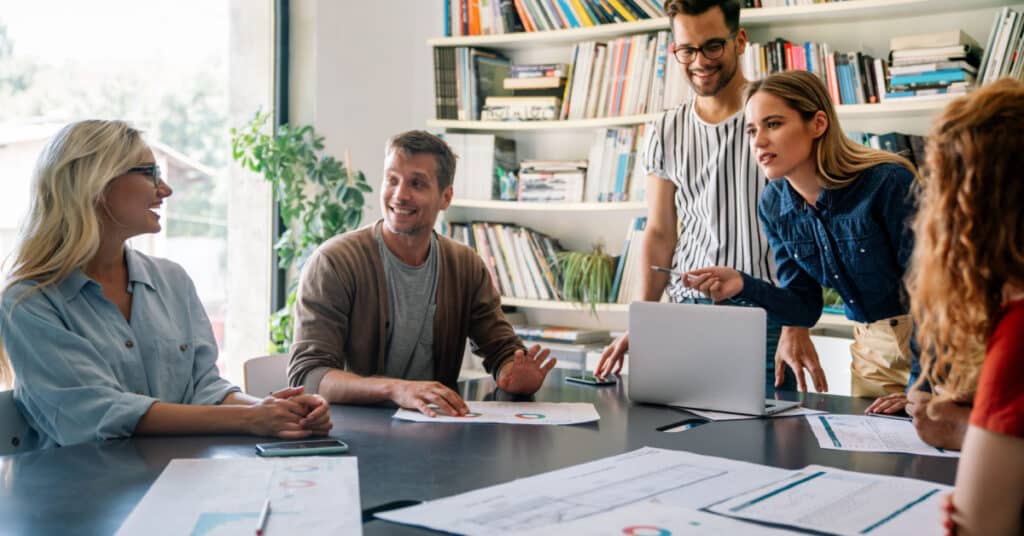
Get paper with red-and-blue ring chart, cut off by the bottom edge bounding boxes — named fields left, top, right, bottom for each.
left=512, top=502, right=795, bottom=536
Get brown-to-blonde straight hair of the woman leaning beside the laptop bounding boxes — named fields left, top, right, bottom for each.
left=743, top=71, right=918, bottom=190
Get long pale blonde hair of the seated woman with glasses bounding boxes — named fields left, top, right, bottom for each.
left=0, top=120, right=146, bottom=382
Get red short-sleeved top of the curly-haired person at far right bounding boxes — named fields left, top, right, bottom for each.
left=971, top=299, right=1024, bottom=438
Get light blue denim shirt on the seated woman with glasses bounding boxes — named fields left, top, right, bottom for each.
left=0, top=249, right=240, bottom=448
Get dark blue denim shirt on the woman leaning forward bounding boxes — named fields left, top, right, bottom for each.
left=739, top=164, right=916, bottom=326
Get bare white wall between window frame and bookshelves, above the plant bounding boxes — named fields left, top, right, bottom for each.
left=290, top=0, right=444, bottom=222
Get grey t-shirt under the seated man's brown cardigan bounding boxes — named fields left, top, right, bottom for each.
left=377, top=235, right=438, bottom=380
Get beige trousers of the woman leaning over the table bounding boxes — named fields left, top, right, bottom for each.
left=850, top=315, right=913, bottom=398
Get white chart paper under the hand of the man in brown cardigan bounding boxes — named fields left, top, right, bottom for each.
left=393, top=402, right=601, bottom=425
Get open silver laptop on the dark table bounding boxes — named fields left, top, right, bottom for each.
left=627, top=301, right=800, bottom=415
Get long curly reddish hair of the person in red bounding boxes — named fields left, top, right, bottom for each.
left=907, top=79, right=1024, bottom=396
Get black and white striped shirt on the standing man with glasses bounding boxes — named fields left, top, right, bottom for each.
left=643, top=100, right=775, bottom=301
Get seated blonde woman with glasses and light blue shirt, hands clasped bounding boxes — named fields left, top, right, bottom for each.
left=0, top=121, right=331, bottom=448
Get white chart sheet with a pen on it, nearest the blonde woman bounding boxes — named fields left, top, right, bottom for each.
left=118, top=456, right=362, bottom=536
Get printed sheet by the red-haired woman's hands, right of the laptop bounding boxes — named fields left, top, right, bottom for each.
left=807, top=415, right=959, bottom=458
